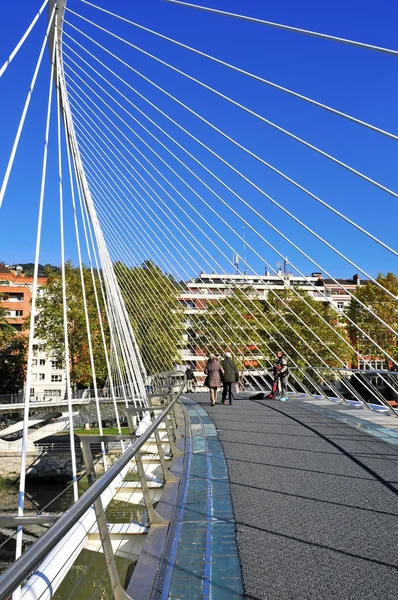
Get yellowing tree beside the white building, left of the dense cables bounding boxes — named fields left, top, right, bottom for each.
left=32, top=263, right=109, bottom=387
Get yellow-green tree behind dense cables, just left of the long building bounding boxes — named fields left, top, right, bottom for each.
left=115, top=260, right=185, bottom=374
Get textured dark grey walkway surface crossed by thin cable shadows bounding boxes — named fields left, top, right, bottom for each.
left=192, top=394, right=398, bottom=600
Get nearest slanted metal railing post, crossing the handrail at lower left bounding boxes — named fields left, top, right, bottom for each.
left=82, top=440, right=132, bottom=600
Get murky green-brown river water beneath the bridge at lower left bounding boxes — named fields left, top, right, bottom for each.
left=0, top=478, right=140, bottom=600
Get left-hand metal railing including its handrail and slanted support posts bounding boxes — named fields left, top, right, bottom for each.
left=0, top=372, right=186, bottom=600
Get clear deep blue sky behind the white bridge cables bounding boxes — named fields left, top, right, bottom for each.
left=0, top=0, right=398, bottom=276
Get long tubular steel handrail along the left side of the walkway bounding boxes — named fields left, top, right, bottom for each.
left=0, top=371, right=185, bottom=600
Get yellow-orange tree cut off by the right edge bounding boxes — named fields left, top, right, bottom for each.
left=347, top=273, right=398, bottom=370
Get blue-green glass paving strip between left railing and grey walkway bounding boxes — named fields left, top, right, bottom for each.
left=158, top=397, right=243, bottom=600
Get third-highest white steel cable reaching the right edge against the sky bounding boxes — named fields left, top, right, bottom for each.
left=65, top=15, right=398, bottom=204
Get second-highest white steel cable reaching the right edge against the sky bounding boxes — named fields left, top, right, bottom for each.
left=82, top=0, right=398, bottom=140
